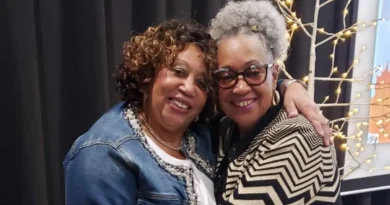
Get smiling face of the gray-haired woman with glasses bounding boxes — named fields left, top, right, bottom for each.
left=217, top=35, right=278, bottom=131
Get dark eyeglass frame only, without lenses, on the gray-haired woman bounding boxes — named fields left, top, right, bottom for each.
left=213, top=64, right=275, bottom=89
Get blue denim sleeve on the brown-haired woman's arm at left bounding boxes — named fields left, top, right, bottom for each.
left=64, top=145, right=137, bottom=205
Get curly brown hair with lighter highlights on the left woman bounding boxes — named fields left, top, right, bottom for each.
left=116, top=19, right=217, bottom=121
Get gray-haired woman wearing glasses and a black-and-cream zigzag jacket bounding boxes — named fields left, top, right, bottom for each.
left=210, top=1, right=341, bottom=205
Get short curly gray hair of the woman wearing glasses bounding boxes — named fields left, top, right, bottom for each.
left=210, top=0, right=289, bottom=63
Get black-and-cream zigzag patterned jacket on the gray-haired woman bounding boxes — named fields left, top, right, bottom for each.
left=215, top=107, right=342, bottom=205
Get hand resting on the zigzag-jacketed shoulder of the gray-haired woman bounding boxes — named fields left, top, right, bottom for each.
left=281, top=80, right=333, bottom=146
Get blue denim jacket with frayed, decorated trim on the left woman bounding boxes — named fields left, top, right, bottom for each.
left=63, top=103, right=216, bottom=205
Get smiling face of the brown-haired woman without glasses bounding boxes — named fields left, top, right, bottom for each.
left=144, top=44, right=207, bottom=132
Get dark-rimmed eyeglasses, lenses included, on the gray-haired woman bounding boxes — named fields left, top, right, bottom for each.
left=214, top=64, right=273, bottom=89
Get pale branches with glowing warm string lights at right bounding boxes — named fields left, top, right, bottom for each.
left=276, top=0, right=390, bottom=178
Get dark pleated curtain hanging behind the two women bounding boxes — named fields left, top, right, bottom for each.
left=0, top=0, right=386, bottom=205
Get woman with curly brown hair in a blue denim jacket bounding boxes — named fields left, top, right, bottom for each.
left=64, top=20, right=332, bottom=205
